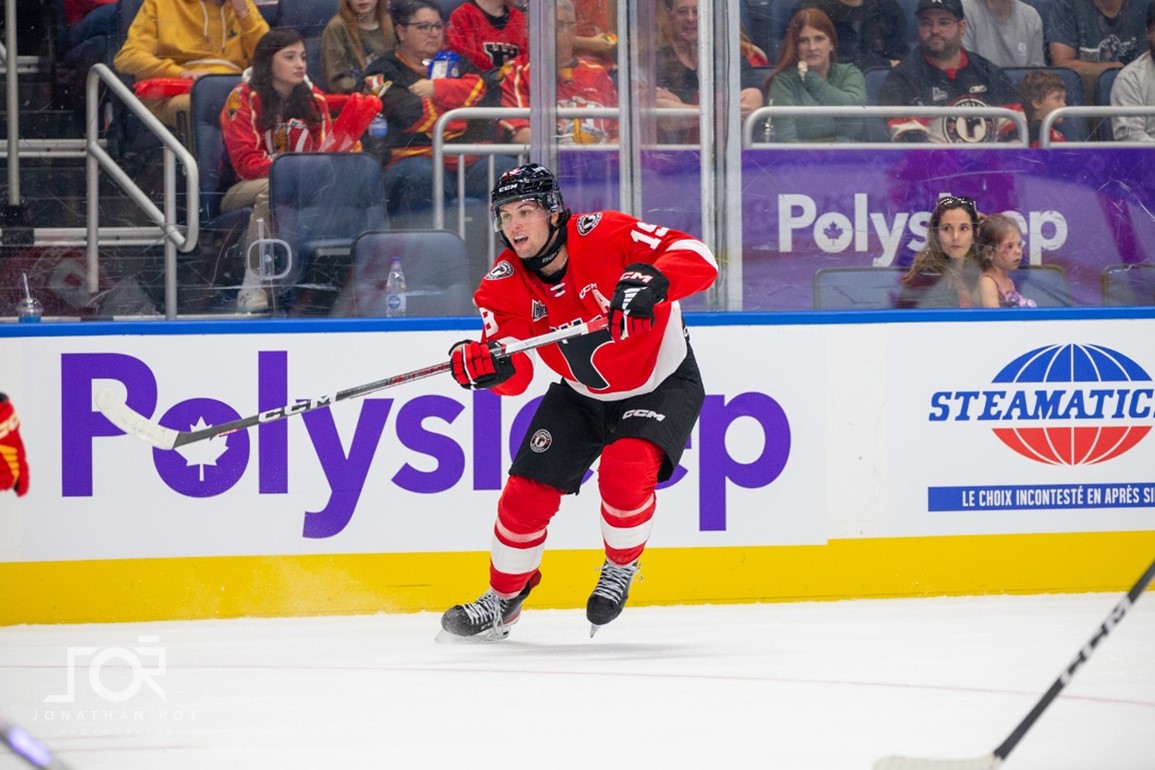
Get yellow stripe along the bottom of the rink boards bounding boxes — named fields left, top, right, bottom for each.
left=0, top=531, right=1155, bottom=626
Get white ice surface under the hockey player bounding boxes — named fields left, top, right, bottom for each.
left=0, top=593, right=1155, bottom=770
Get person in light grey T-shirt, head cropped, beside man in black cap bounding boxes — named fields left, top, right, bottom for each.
left=962, top=0, right=1046, bottom=67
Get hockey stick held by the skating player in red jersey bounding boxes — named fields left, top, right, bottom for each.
left=96, top=317, right=606, bottom=449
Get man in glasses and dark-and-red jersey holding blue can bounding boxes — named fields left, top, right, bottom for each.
left=358, top=0, right=516, bottom=222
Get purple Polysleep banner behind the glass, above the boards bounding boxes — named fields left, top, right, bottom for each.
left=561, top=145, right=1155, bottom=311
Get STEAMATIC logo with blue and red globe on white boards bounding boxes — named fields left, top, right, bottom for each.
left=930, top=344, right=1155, bottom=465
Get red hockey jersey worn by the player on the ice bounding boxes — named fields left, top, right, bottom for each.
left=474, top=211, right=717, bottom=401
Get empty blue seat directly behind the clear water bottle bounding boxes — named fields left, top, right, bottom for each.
left=331, top=230, right=477, bottom=317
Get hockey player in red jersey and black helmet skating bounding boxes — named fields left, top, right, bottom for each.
left=441, top=163, right=717, bottom=638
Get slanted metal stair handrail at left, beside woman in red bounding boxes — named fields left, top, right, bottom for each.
left=85, top=65, right=201, bottom=321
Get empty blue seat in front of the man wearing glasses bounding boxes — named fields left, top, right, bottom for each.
left=269, top=152, right=388, bottom=293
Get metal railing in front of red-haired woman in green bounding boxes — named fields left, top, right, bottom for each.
left=742, top=105, right=1030, bottom=150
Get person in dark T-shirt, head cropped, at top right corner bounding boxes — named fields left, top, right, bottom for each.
left=1043, top=0, right=1149, bottom=90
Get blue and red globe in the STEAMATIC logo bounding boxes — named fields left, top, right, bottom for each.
left=992, top=344, right=1152, bottom=465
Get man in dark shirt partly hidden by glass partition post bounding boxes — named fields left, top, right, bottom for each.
left=654, top=0, right=762, bottom=142
